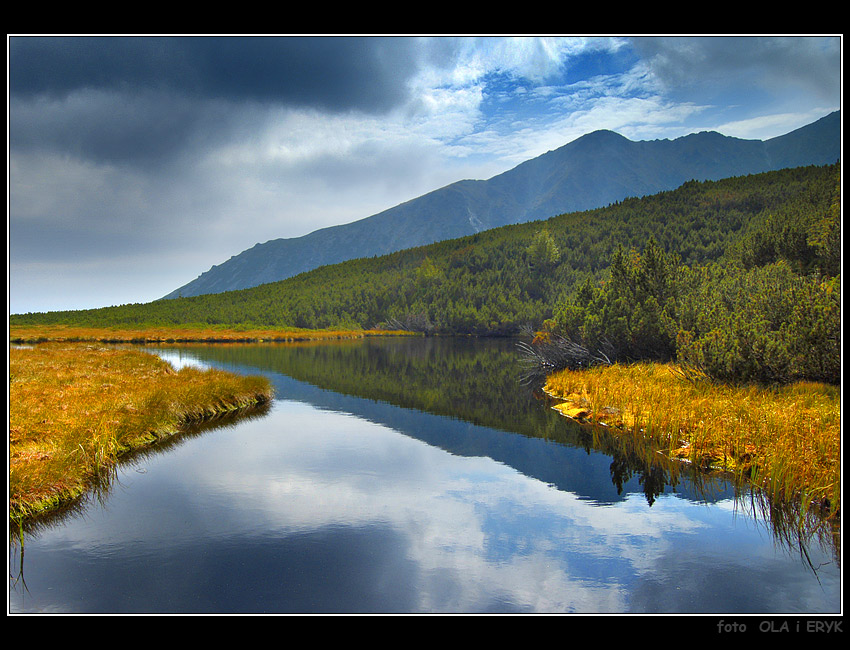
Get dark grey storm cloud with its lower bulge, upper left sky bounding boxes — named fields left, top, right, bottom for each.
left=9, top=37, right=424, bottom=167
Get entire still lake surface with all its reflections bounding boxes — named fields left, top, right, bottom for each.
left=9, top=338, right=841, bottom=614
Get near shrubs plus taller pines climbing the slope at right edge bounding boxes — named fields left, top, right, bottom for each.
left=547, top=162, right=841, bottom=384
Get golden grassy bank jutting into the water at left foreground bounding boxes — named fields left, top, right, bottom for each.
left=9, top=343, right=272, bottom=520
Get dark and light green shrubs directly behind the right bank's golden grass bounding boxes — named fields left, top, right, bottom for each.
left=550, top=246, right=841, bottom=384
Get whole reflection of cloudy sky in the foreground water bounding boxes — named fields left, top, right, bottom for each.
left=11, top=390, right=835, bottom=613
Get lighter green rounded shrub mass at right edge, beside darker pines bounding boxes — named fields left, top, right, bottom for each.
left=677, top=261, right=841, bottom=383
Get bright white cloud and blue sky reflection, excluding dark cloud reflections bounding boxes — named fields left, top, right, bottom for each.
left=149, top=402, right=720, bottom=612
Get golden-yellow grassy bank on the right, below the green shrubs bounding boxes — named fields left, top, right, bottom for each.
left=545, top=363, right=841, bottom=518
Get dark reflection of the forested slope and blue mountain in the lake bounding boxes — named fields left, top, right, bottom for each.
left=147, top=337, right=734, bottom=505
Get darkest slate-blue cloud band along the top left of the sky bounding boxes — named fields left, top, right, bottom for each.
left=9, top=36, right=416, bottom=112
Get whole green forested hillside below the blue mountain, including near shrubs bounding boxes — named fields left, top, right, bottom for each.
left=16, top=164, right=841, bottom=381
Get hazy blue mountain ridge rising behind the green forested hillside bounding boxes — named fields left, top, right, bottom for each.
left=165, top=111, right=841, bottom=298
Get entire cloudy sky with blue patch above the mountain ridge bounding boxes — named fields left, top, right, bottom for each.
left=7, top=36, right=842, bottom=313
